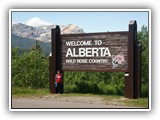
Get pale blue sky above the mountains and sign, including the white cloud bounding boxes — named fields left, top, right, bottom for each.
left=12, top=11, right=148, bottom=32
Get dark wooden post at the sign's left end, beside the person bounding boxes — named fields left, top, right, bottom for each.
left=49, top=26, right=62, bottom=93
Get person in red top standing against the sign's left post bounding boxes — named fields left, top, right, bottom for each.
left=55, top=70, right=62, bottom=94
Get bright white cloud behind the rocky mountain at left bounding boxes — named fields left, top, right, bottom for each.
left=25, top=17, right=53, bottom=27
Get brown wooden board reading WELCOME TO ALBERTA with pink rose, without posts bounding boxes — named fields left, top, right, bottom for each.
left=61, top=32, right=128, bottom=71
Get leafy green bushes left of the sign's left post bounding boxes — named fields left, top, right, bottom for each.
left=12, top=45, right=49, bottom=88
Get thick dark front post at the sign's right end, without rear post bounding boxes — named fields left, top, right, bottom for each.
left=125, top=20, right=137, bottom=98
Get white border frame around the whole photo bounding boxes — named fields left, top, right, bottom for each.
left=9, top=9, right=151, bottom=111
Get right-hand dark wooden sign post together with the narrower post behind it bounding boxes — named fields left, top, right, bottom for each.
left=125, top=21, right=141, bottom=98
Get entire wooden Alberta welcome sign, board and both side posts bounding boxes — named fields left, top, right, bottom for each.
left=49, top=21, right=141, bottom=98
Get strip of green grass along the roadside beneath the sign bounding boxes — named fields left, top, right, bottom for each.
left=12, top=88, right=148, bottom=108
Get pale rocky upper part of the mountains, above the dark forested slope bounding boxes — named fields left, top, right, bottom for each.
left=12, top=23, right=84, bottom=42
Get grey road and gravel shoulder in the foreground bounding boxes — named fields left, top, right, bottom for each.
left=11, top=95, right=144, bottom=109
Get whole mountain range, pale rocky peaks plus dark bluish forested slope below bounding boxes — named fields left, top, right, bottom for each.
left=11, top=23, right=84, bottom=56
